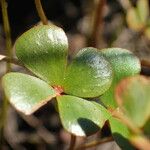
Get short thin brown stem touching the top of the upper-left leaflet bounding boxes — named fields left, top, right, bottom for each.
left=35, top=0, right=48, bottom=25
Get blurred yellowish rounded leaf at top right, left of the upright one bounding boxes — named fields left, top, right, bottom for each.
left=126, top=7, right=144, bottom=32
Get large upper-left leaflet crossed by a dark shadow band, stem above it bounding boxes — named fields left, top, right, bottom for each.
left=15, top=25, right=68, bottom=85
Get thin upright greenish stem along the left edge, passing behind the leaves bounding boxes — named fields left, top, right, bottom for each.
left=0, top=0, right=13, bottom=145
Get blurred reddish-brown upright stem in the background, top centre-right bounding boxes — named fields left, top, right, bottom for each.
left=89, top=0, right=106, bottom=48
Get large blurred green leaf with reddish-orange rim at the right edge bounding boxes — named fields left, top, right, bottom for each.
left=116, top=76, right=150, bottom=128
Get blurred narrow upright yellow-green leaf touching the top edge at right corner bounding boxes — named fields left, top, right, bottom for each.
left=137, top=0, right=149, bottom=24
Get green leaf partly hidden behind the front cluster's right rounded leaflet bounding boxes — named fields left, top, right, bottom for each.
left=100, top=48, right=141, bottom=108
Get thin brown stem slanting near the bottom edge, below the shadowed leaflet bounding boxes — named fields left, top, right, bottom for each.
left=76, top=137, right=114, bottom=150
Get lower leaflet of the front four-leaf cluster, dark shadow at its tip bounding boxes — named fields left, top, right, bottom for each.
left=57, top=95, right=110, bottom=136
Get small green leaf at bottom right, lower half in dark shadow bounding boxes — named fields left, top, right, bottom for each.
left=109, top=117, right=134, bottom=150
